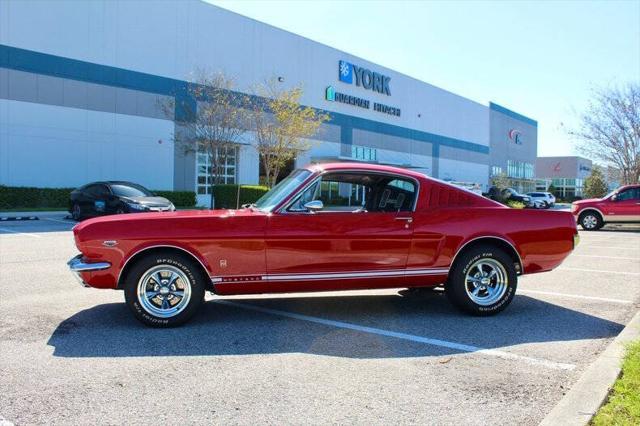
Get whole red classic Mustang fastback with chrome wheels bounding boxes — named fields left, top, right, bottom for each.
left=69, top=163, right=578, bottom=327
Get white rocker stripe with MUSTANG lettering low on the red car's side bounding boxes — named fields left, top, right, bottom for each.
left=211, top=268, right=449, bottom=284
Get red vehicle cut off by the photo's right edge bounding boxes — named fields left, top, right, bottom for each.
left=571, top=185, right=640, bottom=231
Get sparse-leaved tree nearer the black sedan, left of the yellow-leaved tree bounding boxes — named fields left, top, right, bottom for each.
left=163, top=71, right=248, bottom=209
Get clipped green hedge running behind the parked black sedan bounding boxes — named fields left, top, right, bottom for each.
left=0, top=185, right=196, bottom=210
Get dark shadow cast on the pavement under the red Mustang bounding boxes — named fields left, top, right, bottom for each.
left=48, top=292, right=623, bottom=358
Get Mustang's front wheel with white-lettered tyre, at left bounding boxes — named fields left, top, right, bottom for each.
left=124, top=252, right=205, bottom=327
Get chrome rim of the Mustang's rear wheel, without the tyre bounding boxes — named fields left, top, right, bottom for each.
left=465, top=259, right=509, bottom=306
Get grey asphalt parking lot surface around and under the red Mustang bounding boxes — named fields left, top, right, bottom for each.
left=0, top=214, right=640, bottom=425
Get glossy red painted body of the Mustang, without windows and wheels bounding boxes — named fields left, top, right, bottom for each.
left=74, top=163, right=577, bottom=294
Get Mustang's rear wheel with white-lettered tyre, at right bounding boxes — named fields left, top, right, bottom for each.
left=445, top=245, right=518, bottom=316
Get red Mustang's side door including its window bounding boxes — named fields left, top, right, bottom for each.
left=266, top=172, right=417, bottom=291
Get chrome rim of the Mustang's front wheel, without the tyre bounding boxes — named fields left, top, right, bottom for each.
left=137, top=265, right=191, bottom=318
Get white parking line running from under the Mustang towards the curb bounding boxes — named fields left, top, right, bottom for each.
left=214, top=300, right=576, bottom=370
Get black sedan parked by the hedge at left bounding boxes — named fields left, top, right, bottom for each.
left=69, top=181, right=176, bottom=220
